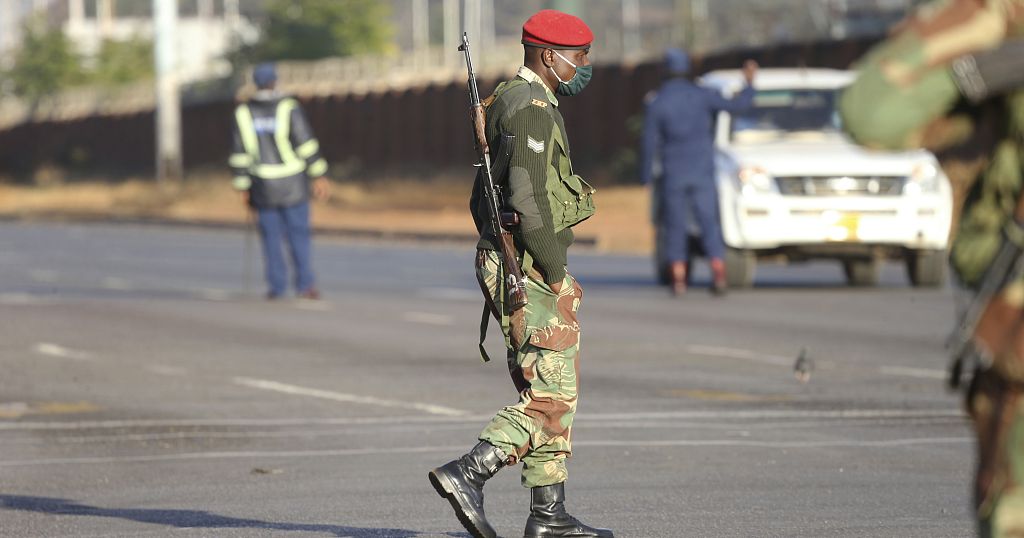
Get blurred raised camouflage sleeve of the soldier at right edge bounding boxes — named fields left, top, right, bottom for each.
left=840, top=0, right=1024, bottom=150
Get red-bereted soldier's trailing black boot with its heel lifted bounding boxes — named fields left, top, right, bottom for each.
left=428, top=441, right=505, bottom=538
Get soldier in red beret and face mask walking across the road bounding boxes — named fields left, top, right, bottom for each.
left=429, top=9, right=612, bottom=538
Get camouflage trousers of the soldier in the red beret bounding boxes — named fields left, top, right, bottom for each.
left=476, top=250, right=583, bottom=488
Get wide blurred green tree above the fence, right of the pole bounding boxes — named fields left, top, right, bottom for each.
left=257, top=0, right=393, bottom=59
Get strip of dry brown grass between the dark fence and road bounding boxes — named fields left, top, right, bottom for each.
left=0, top=175, right=651, bottom=253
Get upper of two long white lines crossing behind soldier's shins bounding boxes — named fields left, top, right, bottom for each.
left=0, top=408, right=967, bottom=430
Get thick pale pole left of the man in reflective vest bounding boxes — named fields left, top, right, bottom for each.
left=153, top=0, right=182, bottom=182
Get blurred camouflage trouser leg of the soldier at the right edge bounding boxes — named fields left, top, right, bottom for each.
left=969, top=371, right=1024, bottom=538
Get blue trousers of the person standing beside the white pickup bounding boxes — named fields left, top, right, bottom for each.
left=662, top=180, right=725, bottom=262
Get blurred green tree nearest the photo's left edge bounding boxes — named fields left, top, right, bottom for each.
left=4, top=18, right=85, bottom=100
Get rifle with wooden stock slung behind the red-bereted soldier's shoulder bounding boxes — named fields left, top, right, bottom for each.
left=459, top=32, right=526, bottom=312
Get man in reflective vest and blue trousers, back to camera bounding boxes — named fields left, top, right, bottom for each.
left=229, top=64, right=329, bottom=299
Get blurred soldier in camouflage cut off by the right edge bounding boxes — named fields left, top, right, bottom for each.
left=841, top=0, right=1024, bottom=537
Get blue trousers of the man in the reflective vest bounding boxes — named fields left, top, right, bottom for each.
left=257, top=202, right=313, bottom=297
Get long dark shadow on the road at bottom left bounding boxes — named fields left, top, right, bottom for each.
left=0, top=495, right=469, bottom=538
